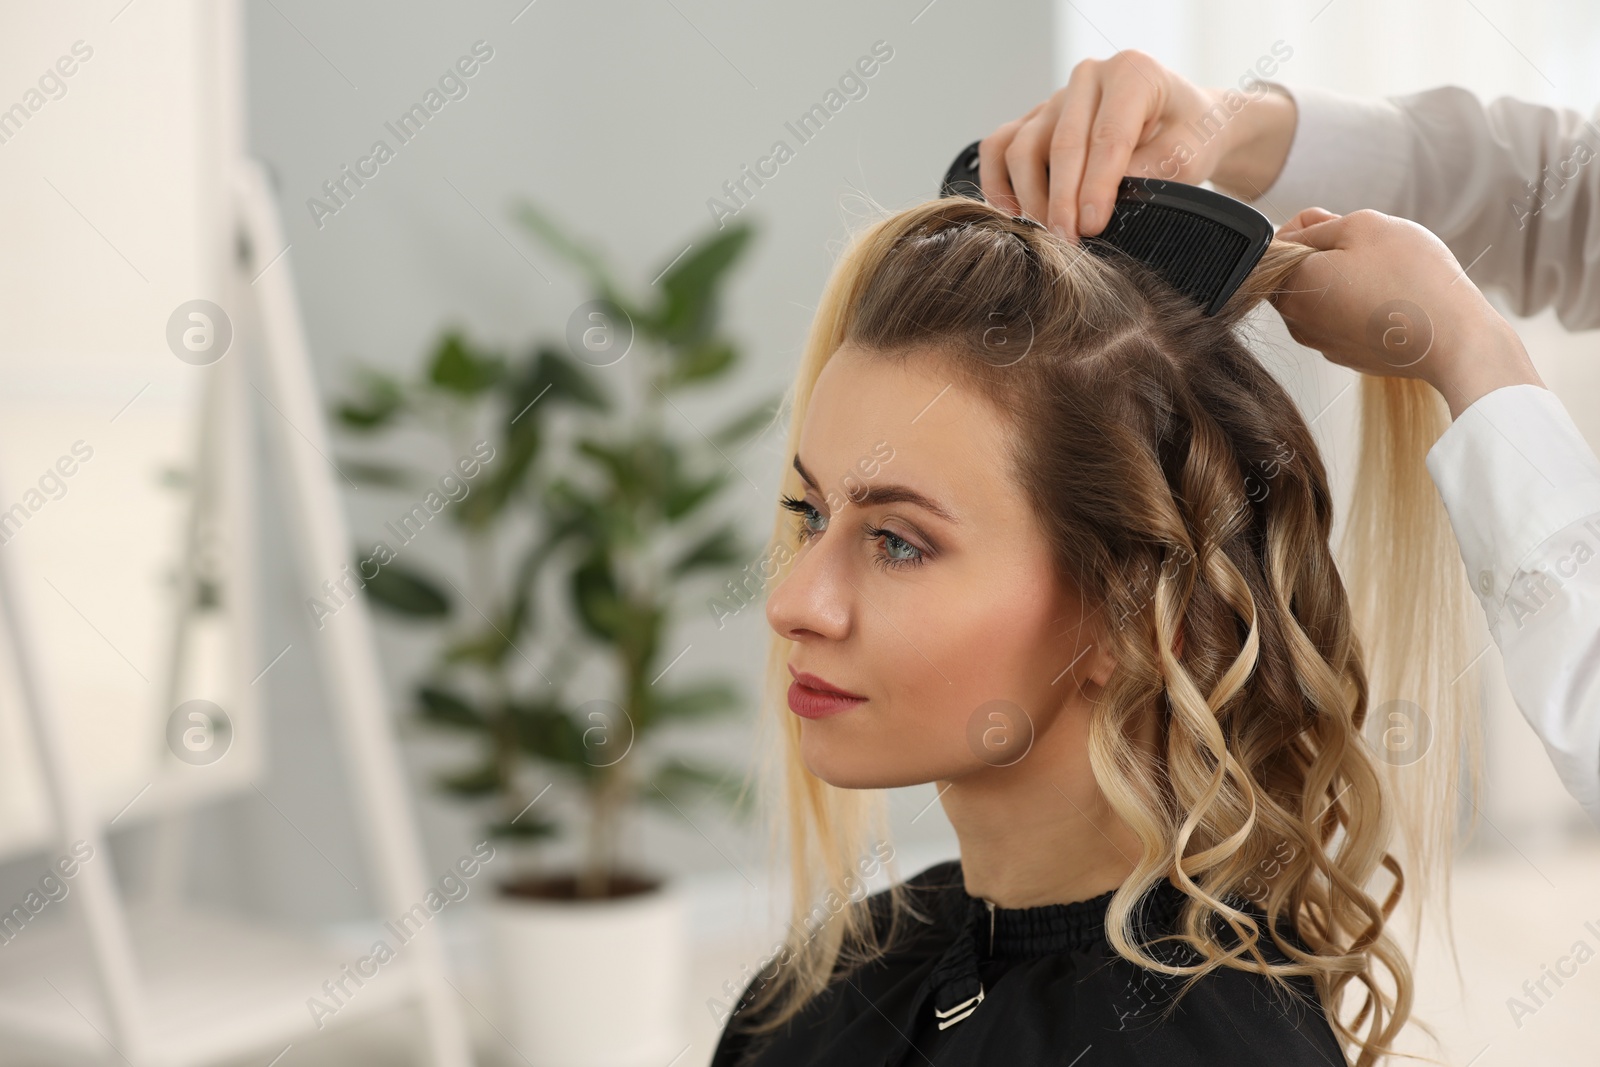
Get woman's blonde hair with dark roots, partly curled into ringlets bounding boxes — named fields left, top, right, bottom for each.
left=734, top=198, right=1475, bottom=1067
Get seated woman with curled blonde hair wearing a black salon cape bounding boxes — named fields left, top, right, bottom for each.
left=712, top=198, right=1458, bottom=1067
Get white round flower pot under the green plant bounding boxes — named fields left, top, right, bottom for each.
left=488, top=881, right=690, bottom=1067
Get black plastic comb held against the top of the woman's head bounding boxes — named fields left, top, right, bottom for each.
left=939, top=141, right=1272, bottom=315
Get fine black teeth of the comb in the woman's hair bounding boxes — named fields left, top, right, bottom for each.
left=1085, top=203, right=1250, bottom=310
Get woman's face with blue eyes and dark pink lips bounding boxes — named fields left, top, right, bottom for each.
left=766, top=344, right=1110, bottom=789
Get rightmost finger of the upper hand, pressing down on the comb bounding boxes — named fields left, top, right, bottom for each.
left=1051, top=51, right=1162, bottom=237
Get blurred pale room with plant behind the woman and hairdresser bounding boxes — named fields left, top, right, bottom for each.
left=0, top=0, right=1600, bottom=1067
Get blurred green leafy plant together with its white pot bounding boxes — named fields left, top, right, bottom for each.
left=336, top=205, right=778, bottom=1067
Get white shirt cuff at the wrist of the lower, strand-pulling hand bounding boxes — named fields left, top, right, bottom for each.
left=1427, top=386, right=1600, bottom=624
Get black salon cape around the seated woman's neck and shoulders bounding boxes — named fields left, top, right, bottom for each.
left=710, top=861, right=1347, bottom=1067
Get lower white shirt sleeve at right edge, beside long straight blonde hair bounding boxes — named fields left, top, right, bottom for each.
left=1427, top=386, right=1600, bottom=824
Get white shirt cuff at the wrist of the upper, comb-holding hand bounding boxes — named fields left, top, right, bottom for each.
left=1254, top=82, right=1410, bottom=226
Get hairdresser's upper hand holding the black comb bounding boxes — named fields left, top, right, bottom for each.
left=978, top=48, right=1296, bottom=242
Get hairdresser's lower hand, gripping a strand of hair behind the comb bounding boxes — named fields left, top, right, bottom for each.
left=1274, top=208, right=1544, bottom=418
